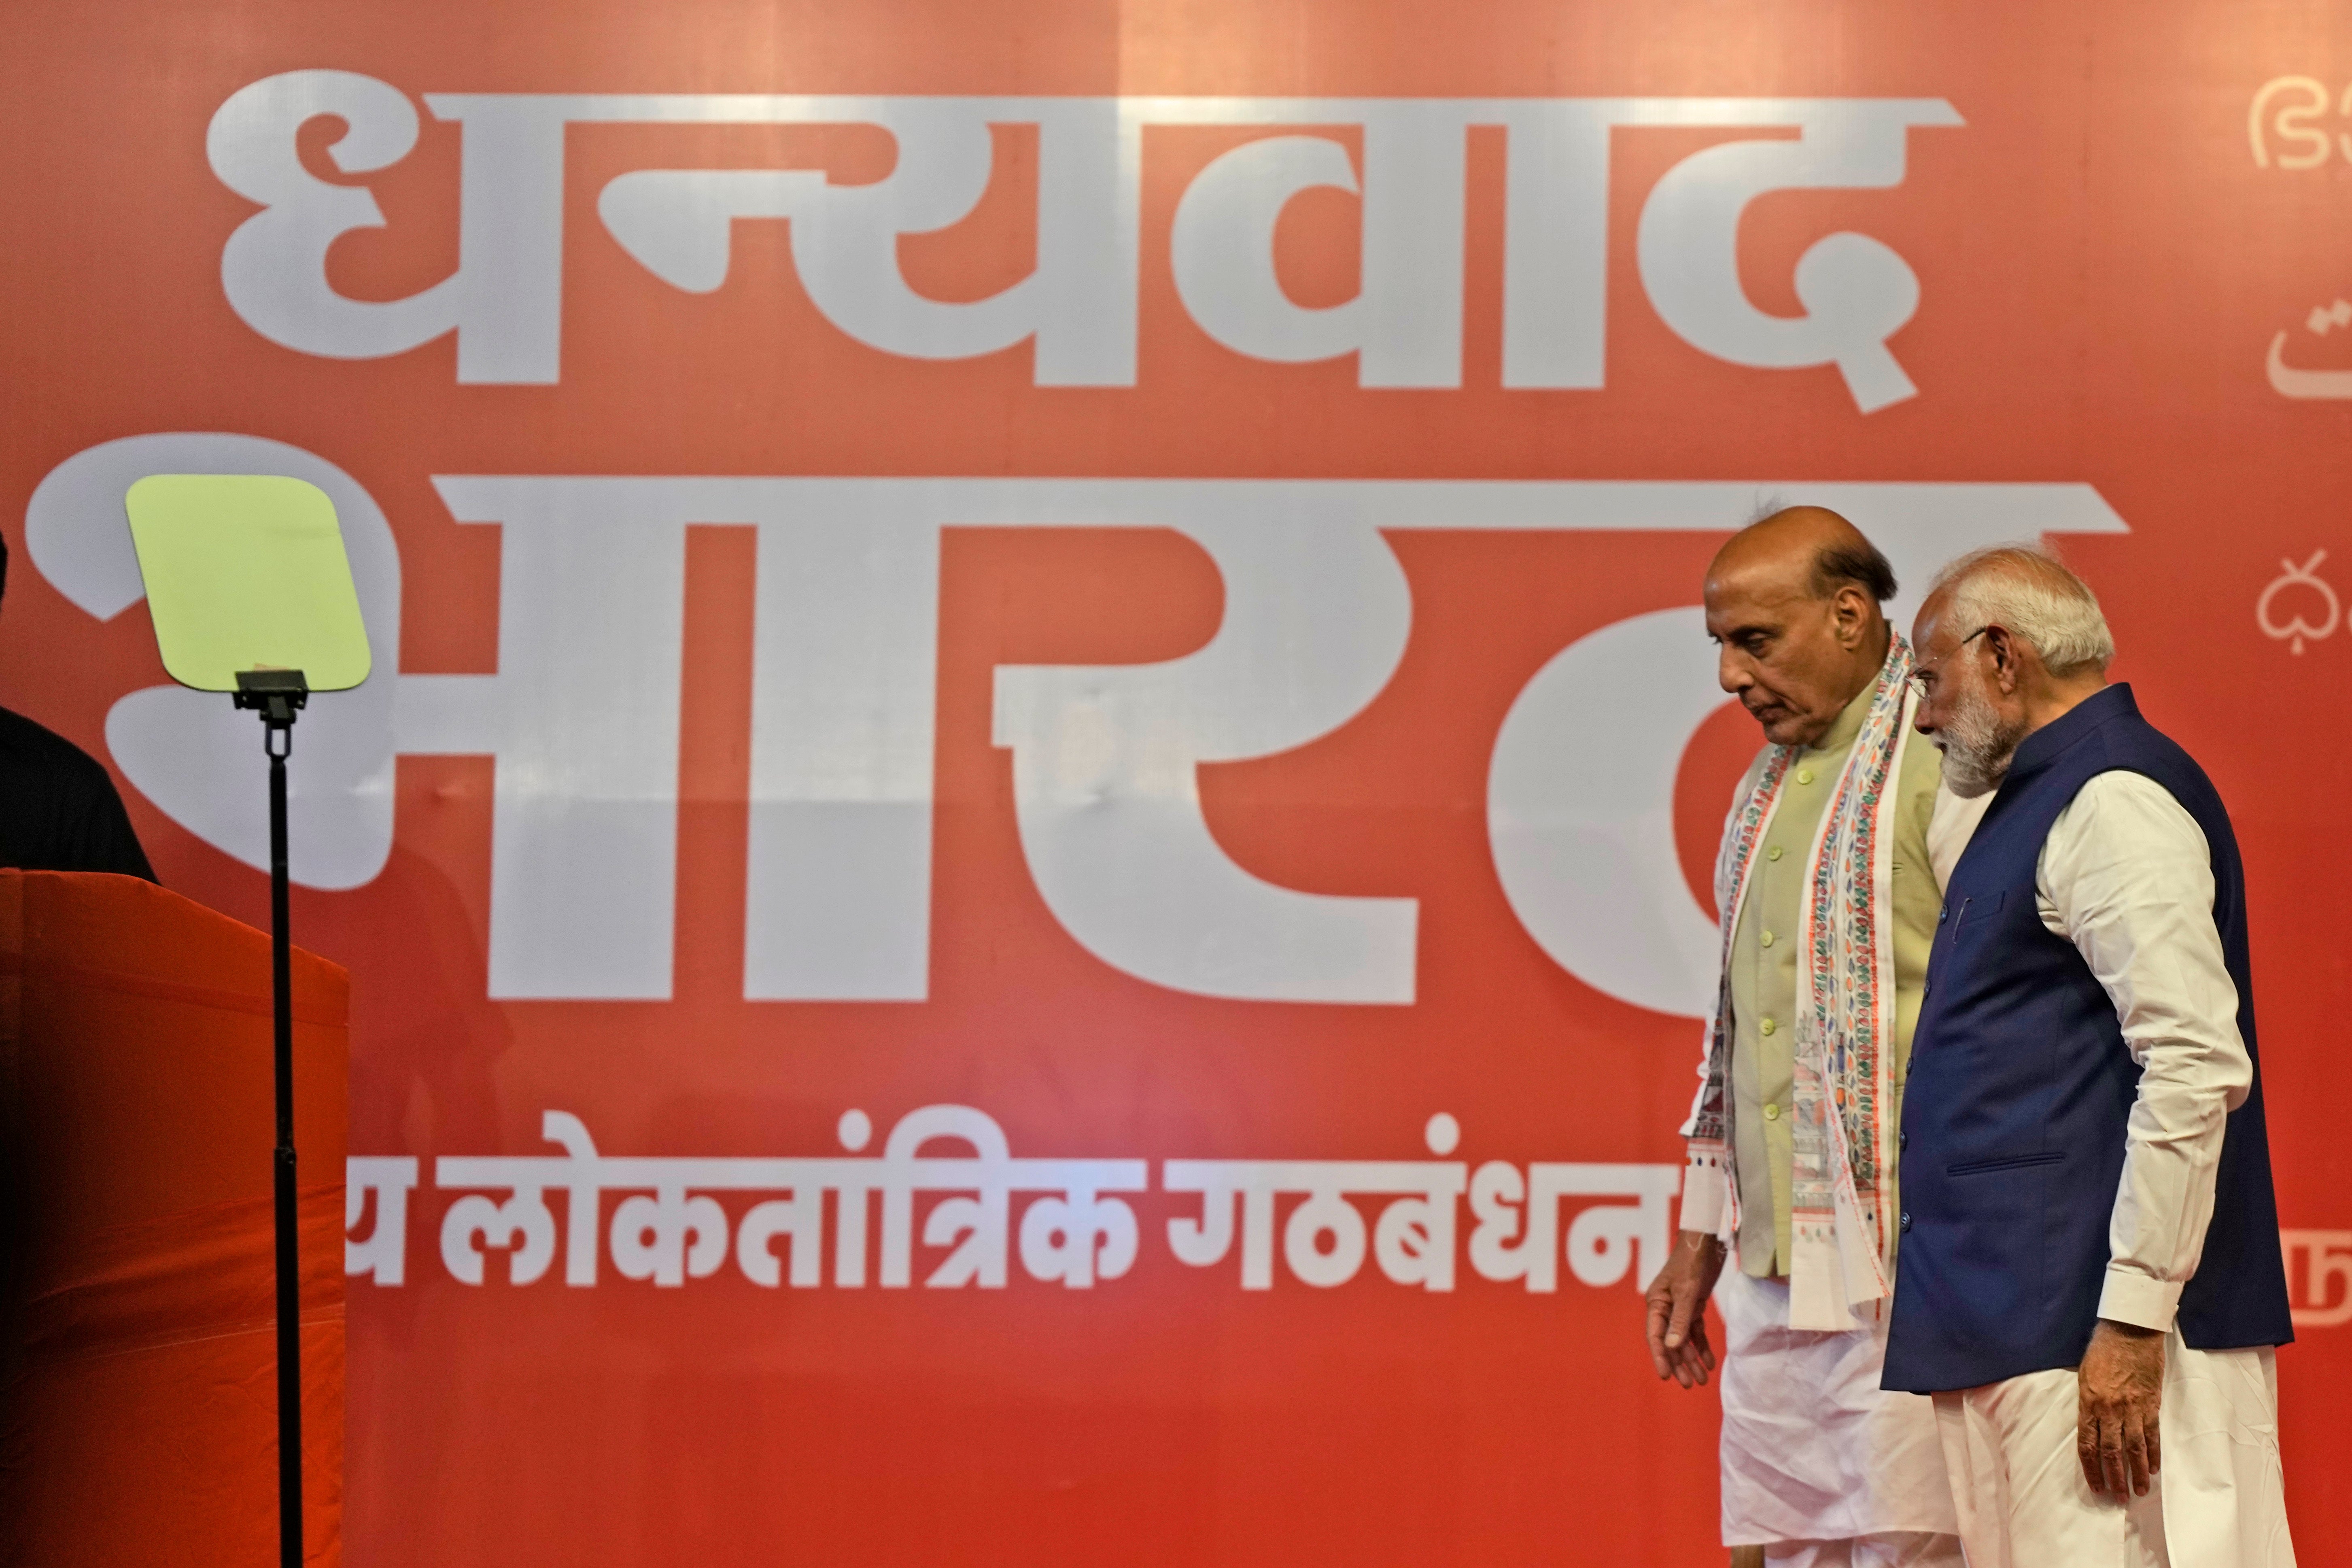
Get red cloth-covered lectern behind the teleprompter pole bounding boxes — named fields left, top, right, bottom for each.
left=0, top=872, right=350, bottom=1568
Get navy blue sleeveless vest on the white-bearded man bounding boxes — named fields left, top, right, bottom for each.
left=1884, top=686, right=2293, bottom=1394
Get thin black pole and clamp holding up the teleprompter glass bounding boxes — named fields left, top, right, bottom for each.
left=233, top=670, right=310, bottom=1568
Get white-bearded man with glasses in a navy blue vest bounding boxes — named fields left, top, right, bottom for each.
left=1884, top=548, right=2293, bottom=1568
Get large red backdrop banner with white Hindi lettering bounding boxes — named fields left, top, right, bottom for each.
left=0, top=0, right=2352, bottom=1568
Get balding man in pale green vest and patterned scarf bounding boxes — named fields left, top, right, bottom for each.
left=1646, top=505, right=1961, bottom=1568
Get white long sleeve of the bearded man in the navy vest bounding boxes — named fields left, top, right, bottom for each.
left=2034, top=771, right=2253, bottom=1330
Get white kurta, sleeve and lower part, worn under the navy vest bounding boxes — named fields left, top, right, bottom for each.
left=1933, top=771, right=2296, bottom=1568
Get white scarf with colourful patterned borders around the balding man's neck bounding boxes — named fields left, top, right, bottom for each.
left=1684, top=635, right=1917, bottom=1330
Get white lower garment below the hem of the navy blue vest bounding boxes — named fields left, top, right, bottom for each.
left=1933, top=1328, right=2296, bottom=1568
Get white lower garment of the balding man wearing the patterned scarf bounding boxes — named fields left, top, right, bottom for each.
left=1715, top=1265, right=1959, bottom=1568
